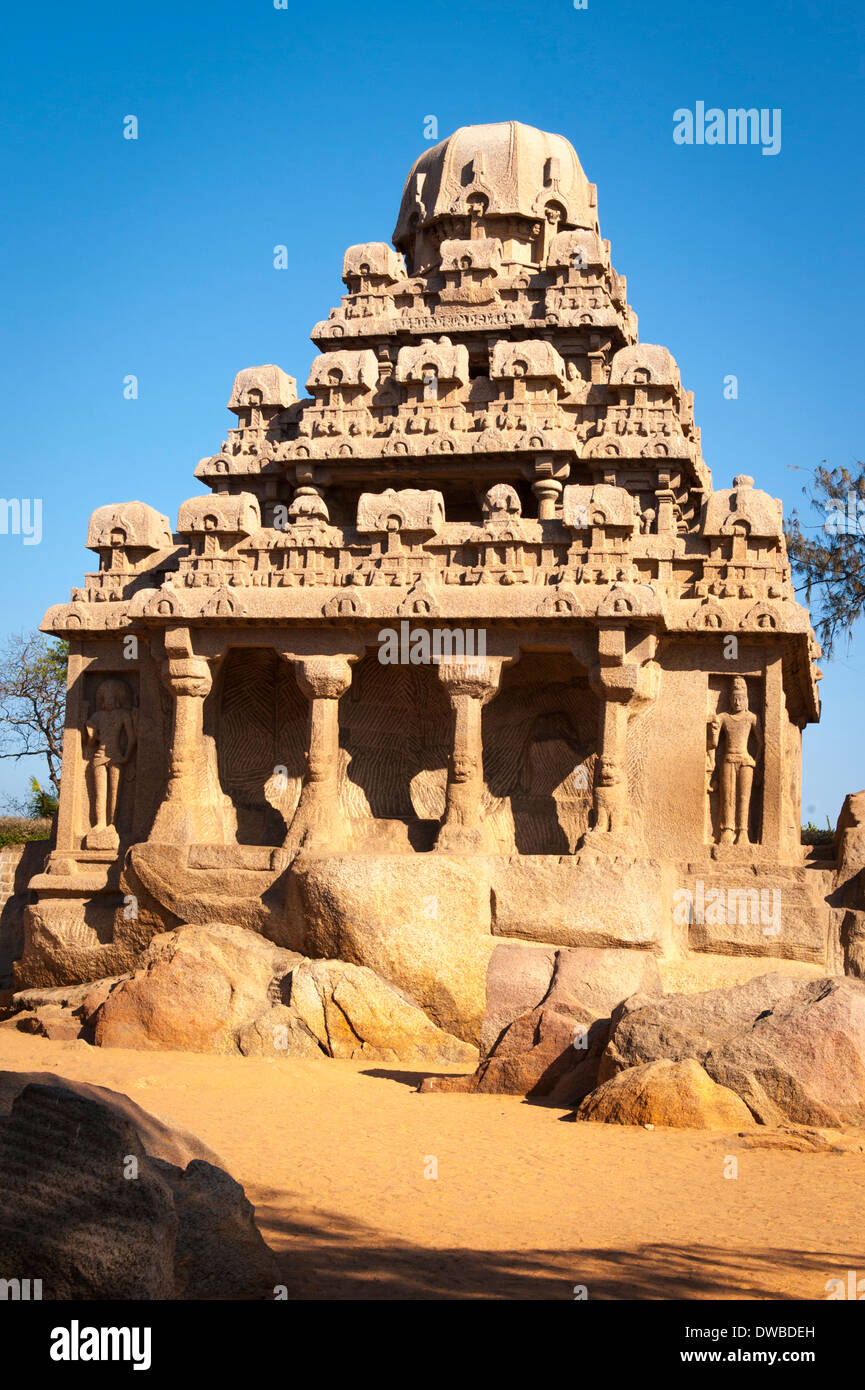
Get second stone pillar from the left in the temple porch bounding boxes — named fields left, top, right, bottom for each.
left=279, top=656, right=352, bottom=867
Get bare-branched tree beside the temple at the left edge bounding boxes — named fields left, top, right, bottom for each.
left=0, top=632, right=70, bottom=795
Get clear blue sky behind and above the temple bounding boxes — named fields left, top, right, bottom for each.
left=0, top=0, right=865, bottom=821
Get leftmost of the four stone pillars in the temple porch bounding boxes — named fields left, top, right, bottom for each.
left=147, top=628, right=236, bottom=845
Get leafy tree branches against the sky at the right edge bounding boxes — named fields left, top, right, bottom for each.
left=786, top=463, right=865, bottom=656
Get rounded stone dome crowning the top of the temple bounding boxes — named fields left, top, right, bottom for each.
left=394, top=121, right=598, bottom=271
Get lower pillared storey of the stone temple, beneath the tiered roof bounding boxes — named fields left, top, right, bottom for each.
left=20, top=621, right=826, bottom=984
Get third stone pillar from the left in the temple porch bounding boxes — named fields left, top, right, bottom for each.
left=435, top=656, right=503, bottom=853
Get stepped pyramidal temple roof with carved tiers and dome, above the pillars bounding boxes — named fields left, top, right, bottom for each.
left=46, top=121, right=818, bottom=717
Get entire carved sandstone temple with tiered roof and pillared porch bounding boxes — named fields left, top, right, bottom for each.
left=18, top=122, right=841, bottom=1041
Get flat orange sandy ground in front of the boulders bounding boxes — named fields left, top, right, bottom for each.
left=0, top=1029, right=865, bottom=1300
